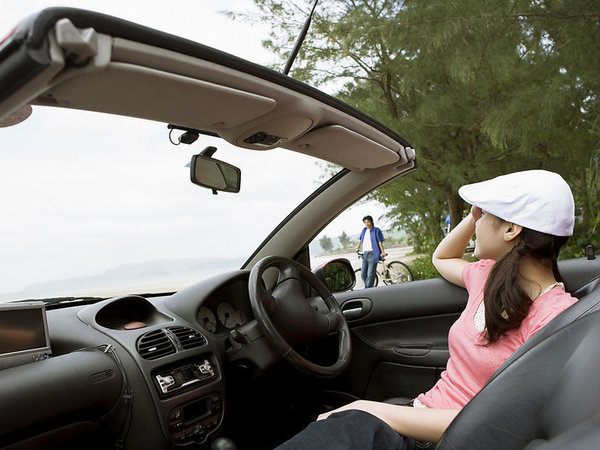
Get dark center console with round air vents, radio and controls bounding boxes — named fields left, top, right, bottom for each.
left=77, top=295, right=225, bottom=448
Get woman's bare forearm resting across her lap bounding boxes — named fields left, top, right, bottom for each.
left=317, top=400, right=460, bottom=442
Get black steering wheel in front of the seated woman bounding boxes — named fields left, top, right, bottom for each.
left=248, top=256, right=352, bottom=377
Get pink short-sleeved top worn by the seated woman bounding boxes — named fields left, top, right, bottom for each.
left=417, top=259, right=577, bottom=409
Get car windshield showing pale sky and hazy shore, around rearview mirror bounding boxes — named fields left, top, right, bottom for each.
left=0, top=107, right=325, bottom=301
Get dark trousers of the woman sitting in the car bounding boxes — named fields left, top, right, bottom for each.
left=277, top=410, right=415, bottom=450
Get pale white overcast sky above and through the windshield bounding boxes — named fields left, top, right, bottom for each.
left=0, top=0, right=394, bottom=298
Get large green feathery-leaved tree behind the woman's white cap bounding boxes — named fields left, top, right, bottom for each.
left=237, top=0, right=600, bottom=251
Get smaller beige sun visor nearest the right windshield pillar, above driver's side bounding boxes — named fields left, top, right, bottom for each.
left=286, top=125, right=400, bottom=170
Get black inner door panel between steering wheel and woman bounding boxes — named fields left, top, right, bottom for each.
left=338, top=278, right=467, bottom=400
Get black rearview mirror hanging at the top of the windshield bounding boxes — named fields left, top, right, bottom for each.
left=190, top=155, right=242, bottom=194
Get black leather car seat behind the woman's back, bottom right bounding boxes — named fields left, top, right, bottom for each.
left=436, top=296, right=600, bottom=450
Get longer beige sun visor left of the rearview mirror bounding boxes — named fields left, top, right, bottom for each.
left=37, top=62, right=277, bottom=132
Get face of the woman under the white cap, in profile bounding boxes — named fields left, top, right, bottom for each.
left=475, top=211, right=516, bottom=261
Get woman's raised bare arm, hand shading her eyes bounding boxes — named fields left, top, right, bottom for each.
left=432, top=206, right=481, bottom=287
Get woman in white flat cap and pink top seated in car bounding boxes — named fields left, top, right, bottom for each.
left=280, top=170, right=576, bottom=449
